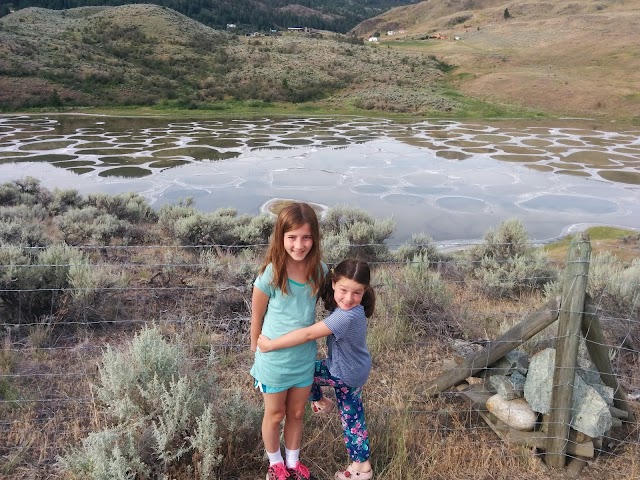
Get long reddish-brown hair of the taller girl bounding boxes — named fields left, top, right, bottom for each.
left=260, top=202, right=324, bottom=295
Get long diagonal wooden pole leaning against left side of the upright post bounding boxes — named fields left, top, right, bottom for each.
left=423, top=298, right=560, bottom=396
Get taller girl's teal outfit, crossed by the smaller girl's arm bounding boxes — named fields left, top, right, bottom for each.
left=251, top=263, right=327, bottom=390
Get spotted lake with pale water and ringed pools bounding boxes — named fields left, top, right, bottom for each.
left=0, top=115, right=640, bottom=246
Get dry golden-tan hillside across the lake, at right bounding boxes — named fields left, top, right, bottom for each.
left=353, top=0, right=640, bottom=121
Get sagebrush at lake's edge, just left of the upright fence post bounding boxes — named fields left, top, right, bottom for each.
left=468, top=219, right=557, bottom=297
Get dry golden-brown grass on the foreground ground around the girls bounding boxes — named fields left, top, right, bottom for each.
left=0, top=248, right=640, bottom=480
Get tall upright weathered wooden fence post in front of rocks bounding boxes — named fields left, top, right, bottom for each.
left=545, top=232, right=591, bottom=468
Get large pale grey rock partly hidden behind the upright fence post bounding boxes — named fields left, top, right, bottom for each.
left=524, top=348, right=613, bottom=437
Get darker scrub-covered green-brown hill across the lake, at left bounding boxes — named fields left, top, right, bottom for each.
left=0, top=5, right=464, bottom=113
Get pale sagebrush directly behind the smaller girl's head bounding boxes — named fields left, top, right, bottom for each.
left=321, top=206, right=395, bottom=263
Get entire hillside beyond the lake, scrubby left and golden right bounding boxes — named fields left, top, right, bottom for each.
left=0, top=0, right=640, bottom=118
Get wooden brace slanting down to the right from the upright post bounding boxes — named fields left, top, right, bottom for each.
left=582, top=295, right=635, bottom=422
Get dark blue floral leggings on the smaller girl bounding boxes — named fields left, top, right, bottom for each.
left=309, top=360, right=369, bottom=462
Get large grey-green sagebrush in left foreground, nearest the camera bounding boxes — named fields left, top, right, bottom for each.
left=58, top=327, right=222, bottom=480
